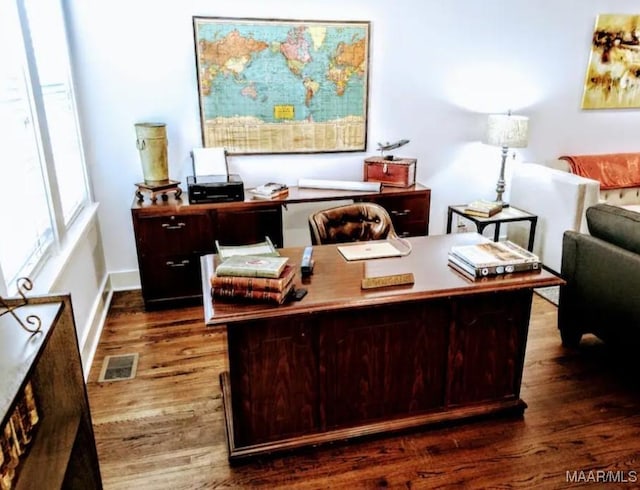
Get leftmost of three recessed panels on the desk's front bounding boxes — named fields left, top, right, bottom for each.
left=227, top=316, right=323, bottom=446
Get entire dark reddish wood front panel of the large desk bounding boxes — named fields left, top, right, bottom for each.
left=228, top=291, right=531, bottom=448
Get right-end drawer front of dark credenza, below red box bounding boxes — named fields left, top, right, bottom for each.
left=364, top=192, right=430, bottom=236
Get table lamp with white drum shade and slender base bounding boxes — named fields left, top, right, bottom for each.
left=485, top=111, right=529, bottom=207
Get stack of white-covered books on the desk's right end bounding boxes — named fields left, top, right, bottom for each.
left=449, top=241, right=541, bottom=279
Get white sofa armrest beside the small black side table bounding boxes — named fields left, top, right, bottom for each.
left=508, top=163, right=600, bottom=271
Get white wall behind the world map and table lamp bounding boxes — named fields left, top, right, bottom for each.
left=68, top=0, right=640, bottom=280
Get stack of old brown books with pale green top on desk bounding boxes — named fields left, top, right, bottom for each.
left=211, top=255, right=296, bottom=304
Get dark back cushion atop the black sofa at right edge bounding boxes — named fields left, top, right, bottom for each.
left=587, top=204, right=640, bottom=254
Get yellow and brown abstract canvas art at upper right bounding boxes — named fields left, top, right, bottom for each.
left=582, top=14, right=640, bottom=109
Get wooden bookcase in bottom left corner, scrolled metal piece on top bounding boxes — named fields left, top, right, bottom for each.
left=0, top=295, right=102, bottom=490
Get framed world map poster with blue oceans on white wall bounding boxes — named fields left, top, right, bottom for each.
left=193, top=17, right=370, bottom=154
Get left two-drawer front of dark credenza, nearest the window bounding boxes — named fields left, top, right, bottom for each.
left=134, top=212, right=215, bottom=306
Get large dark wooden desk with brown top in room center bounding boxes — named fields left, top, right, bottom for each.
left=202, top=233, right=563, bottom=461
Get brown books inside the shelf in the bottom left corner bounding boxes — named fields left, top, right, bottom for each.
left=0, top=382, right=40, bottom=489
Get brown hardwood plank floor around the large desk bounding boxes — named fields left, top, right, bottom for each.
left=88, top=292, right=640, bottom=490
